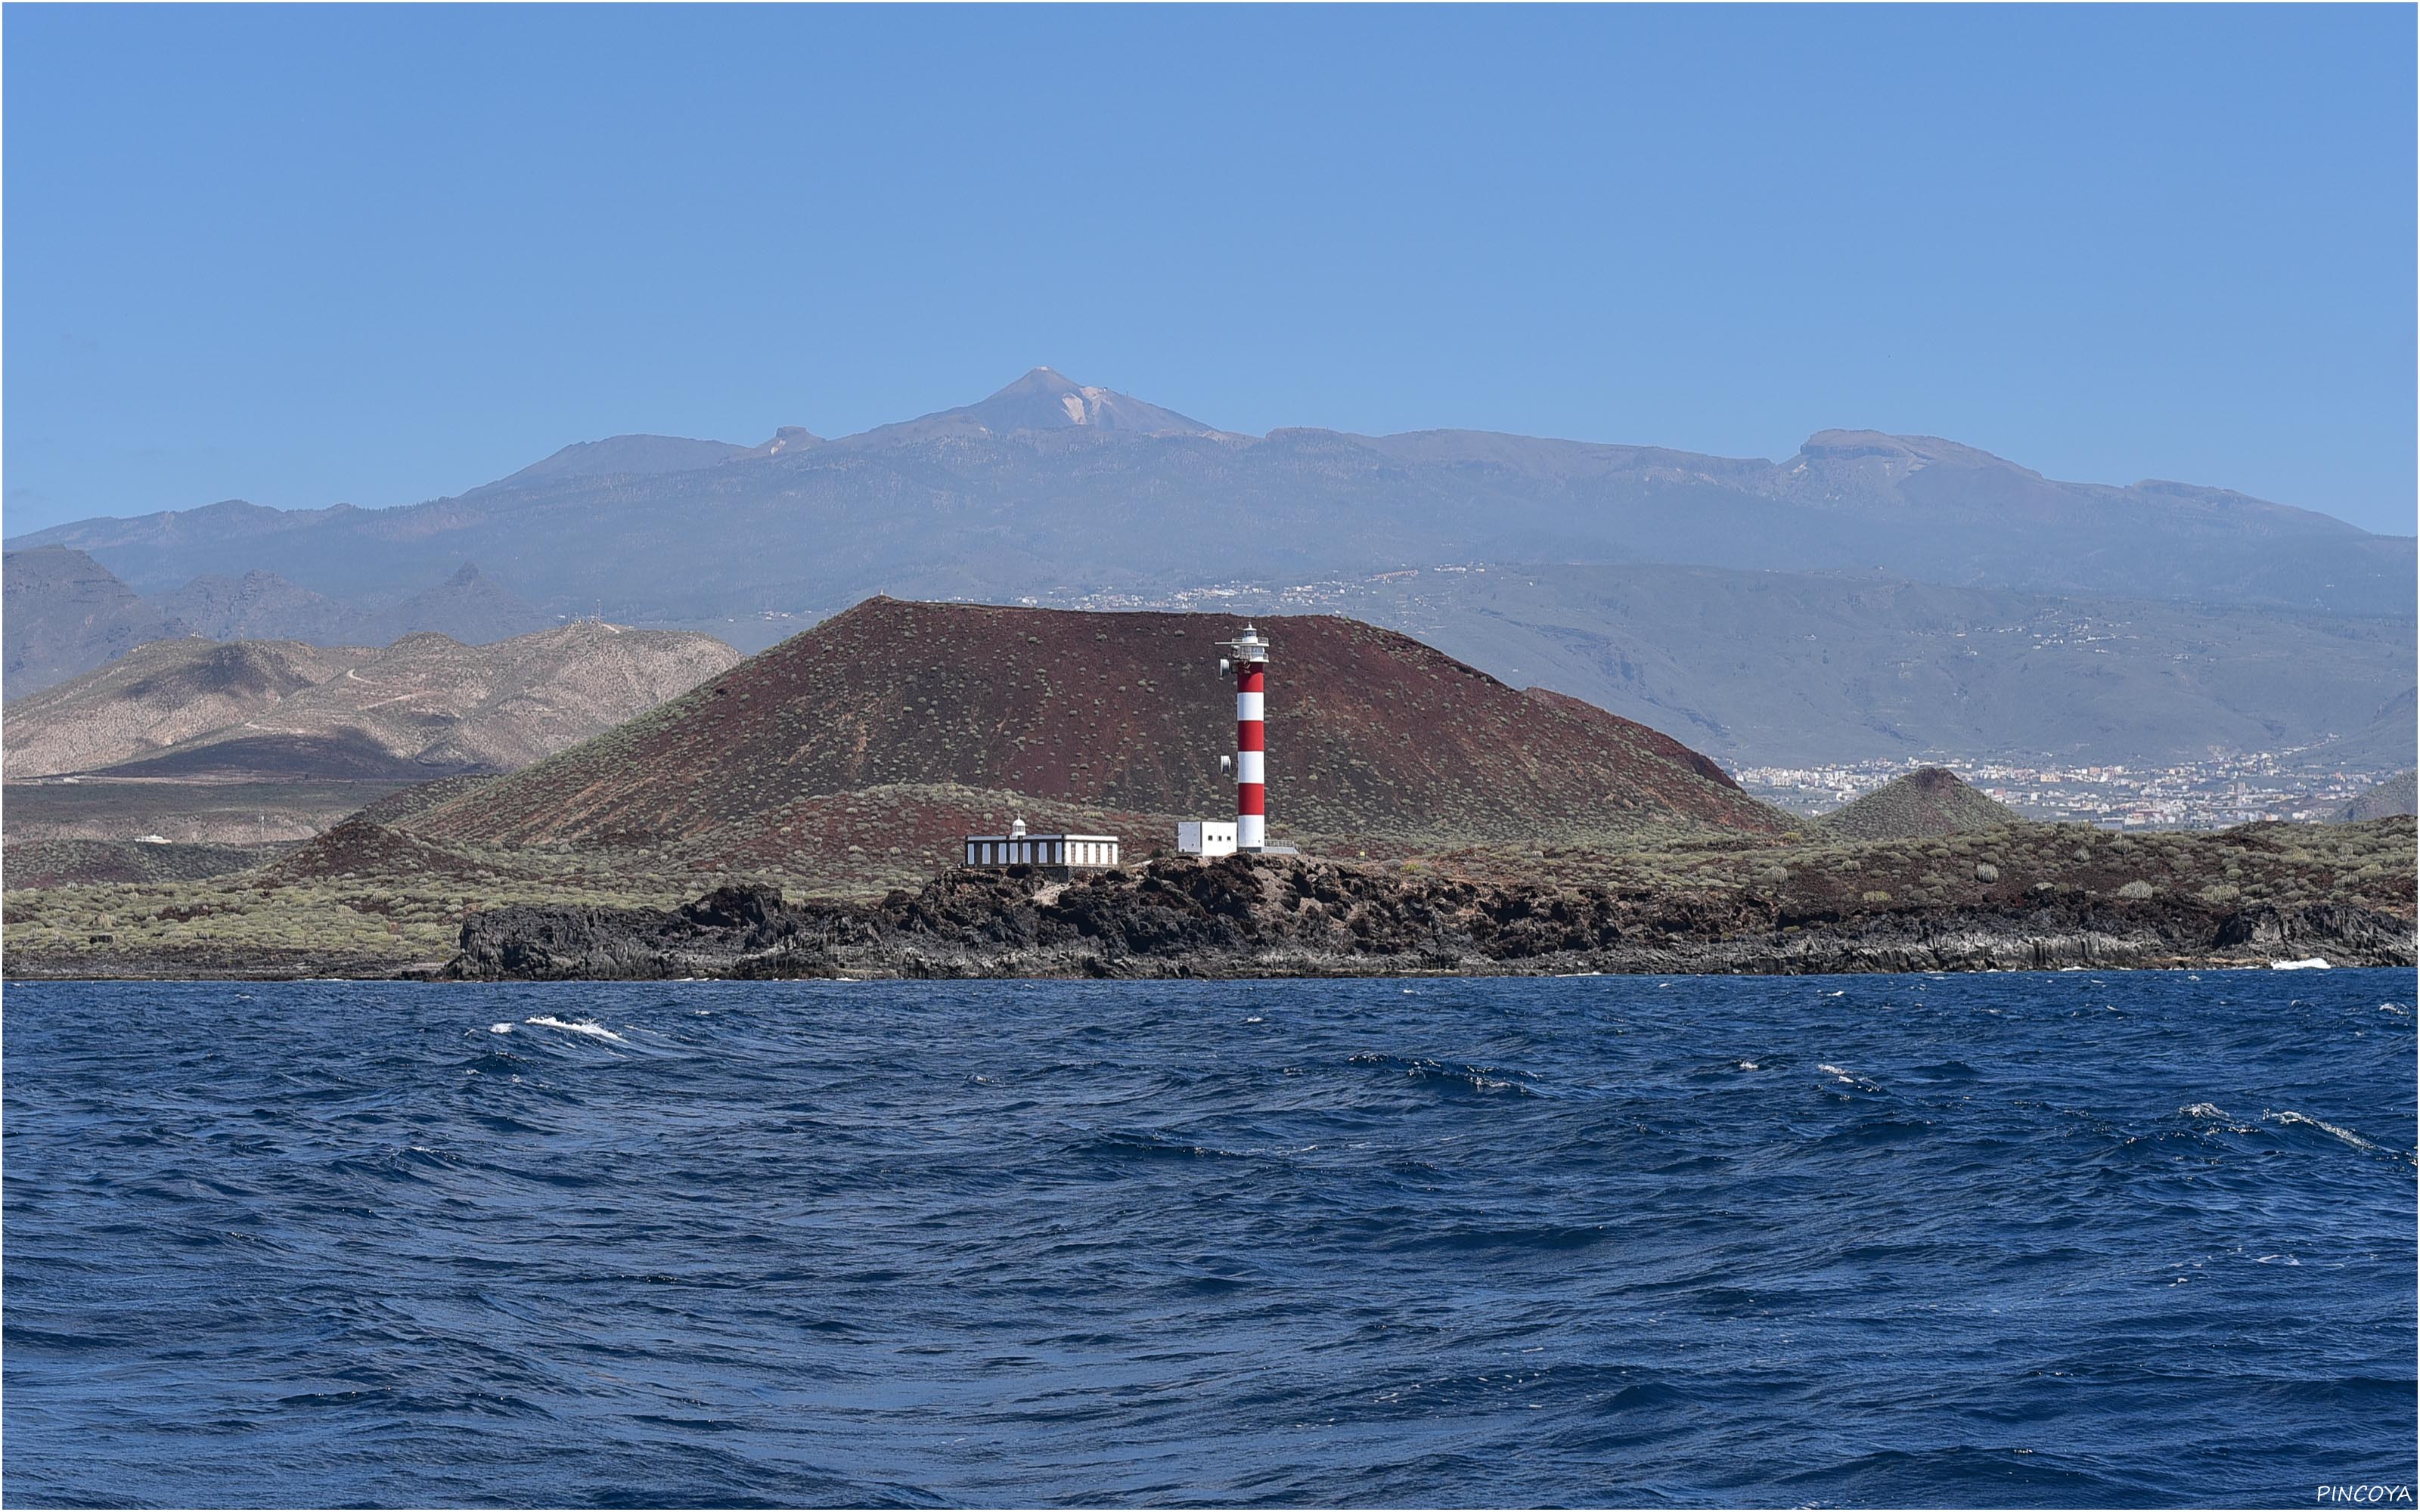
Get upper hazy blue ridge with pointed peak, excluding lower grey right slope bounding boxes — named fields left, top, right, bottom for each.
left=10, top=370, right=2415, bottom=621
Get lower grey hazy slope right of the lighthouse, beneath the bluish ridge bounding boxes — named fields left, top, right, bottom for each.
left=1200, top=566, right=2415, bottom=772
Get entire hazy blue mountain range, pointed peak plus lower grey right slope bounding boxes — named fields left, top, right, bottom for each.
left=8, top=367, right=2415, bottom=767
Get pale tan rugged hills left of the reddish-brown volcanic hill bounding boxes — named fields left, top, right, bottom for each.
left=8, top=621, right=738, bottom=779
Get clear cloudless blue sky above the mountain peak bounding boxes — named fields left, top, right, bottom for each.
left=0, top=5, right=2415, bottom=534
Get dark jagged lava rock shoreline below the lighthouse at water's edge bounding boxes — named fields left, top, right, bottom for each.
left=440, top=857, right=2415, bottom=982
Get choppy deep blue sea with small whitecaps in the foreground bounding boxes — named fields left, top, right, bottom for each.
left=5, top=970, right=2420, bottom=1504
